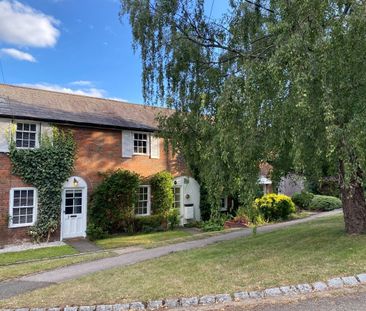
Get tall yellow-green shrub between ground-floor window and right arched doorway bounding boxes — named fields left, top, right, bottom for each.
left=150, top=172, right=174, bottom=218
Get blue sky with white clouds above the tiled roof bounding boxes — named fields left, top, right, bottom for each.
left=0, top=0, right=226, bottom=103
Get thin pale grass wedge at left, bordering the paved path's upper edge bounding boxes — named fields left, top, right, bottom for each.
left=0, top=252, right=114, bottom=282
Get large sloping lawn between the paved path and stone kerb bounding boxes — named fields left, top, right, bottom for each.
left=0, top=216, right=366, bottom=307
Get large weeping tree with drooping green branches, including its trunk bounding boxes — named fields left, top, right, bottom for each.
left=121, top=0, right=366, bottom=234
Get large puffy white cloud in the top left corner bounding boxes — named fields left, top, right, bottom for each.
left=0, top=0, right=60, bottom=47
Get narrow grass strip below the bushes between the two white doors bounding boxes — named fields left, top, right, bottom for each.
left=95, top=230, right=192, bottom=249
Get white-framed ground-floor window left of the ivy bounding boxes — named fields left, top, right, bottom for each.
left=9, top=188, right=37, bottom=228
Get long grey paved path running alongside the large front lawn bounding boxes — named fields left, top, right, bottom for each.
left=0, top=210, right=341, bottom=299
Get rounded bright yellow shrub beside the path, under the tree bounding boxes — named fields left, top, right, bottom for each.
left=253, top=193, right=296, bottom=221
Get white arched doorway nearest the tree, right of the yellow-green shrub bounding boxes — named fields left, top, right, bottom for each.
left=174, top=176, right=201, bottom=225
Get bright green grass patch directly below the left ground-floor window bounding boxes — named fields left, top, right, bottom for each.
left=0, top=245, right=78, bottom=266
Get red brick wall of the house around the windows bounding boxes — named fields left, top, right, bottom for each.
left=0, top=127, right=186, bottom=246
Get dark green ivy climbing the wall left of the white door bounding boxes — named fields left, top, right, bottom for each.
left=9, top=128, right=76, bottom=242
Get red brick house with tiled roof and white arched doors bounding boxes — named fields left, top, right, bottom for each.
left=0, top=84, right=200, bottom=245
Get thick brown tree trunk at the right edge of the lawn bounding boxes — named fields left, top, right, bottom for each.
left=339, top=161, right=366, bottom=234
